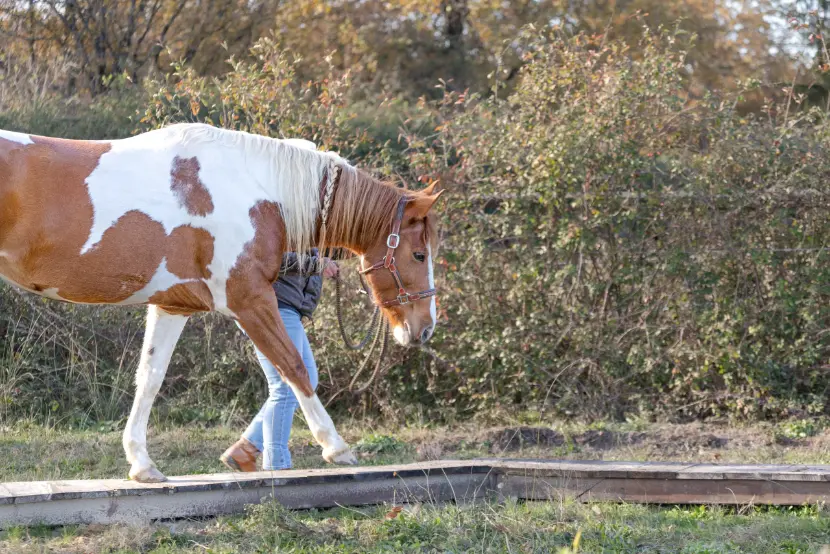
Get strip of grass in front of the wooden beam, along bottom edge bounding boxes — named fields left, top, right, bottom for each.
left=0, top=494, right=830, bottom=554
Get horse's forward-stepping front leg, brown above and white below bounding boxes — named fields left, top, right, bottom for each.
left=235, top=284, right=357, bottom=465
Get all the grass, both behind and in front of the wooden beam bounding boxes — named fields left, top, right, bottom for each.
left=0, top=422, right=830, bottom=554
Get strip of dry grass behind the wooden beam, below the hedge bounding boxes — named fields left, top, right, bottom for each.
left=0, top=418, right=830, bottom=481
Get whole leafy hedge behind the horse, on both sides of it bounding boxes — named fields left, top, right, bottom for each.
left=0, top=24, right=830, bottom=421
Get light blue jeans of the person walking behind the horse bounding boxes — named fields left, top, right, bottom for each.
left=242, top=308, right=318, bottom=470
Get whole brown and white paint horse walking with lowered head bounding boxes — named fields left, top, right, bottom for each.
left=0, top=124, right=438, bottom=482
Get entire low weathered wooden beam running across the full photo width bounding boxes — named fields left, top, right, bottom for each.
left=0, top=459, right=830, bottom=528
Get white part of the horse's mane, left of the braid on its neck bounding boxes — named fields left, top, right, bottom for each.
left=169, top=124, right=350, bottom=257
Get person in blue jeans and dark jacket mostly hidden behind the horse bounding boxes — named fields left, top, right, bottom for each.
left=219, top=248, right=340, bottom=472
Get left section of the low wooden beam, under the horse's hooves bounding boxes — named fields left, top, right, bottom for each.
left=0, top=462, right=495, bottom=528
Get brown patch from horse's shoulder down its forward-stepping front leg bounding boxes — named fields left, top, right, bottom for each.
left=227, top=201, right=314, bottom=396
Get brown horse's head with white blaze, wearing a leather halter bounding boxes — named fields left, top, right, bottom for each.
left=362, top=187, right=443, bottom=346
